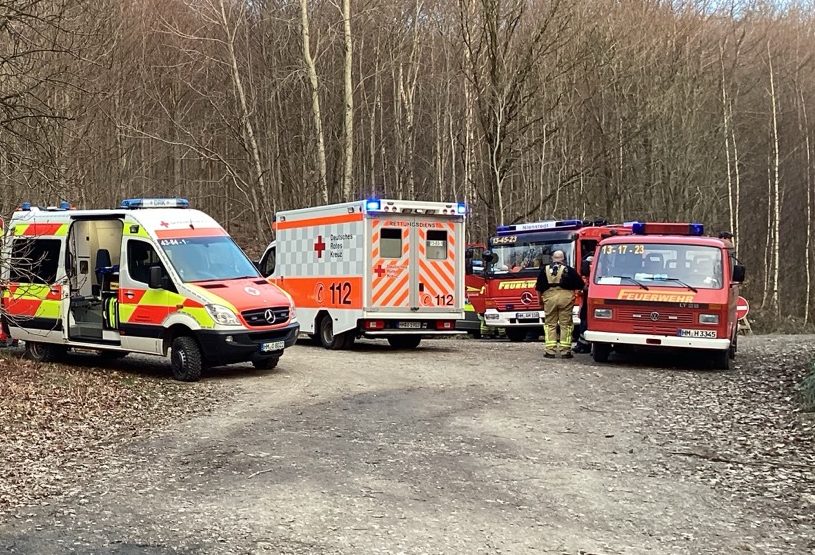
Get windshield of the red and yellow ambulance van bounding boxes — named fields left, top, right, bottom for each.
left=159, top=236, right=259, bottom=282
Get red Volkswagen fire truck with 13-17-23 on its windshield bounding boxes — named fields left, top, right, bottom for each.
left=586, top=223, right=745, bottom=369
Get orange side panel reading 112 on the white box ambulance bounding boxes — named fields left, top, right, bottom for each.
left=274, top=276, right=363, bottom=309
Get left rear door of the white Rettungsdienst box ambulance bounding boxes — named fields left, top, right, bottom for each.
left=366, top=218, right=413, bottom=312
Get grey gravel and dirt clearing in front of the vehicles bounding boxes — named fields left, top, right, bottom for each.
left=0, top=336, right=815, bottom=554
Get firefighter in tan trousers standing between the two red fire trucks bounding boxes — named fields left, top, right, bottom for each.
left=535, top=251, right=585, bottom=358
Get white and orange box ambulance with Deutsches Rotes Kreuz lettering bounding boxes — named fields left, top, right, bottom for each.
left=258, top=199, right=466, bottom=349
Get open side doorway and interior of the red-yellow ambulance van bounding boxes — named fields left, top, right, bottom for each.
left=66, top=219, right=124, bottom=342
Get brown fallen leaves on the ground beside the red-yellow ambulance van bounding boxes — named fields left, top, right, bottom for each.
left=0, top=351, right=222, bottom=512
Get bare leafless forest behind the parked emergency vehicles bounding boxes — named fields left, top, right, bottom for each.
left=0, top=0, right=815, bottom=331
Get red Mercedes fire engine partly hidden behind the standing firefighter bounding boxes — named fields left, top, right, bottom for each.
left=483, top=220, right=631, bottom=341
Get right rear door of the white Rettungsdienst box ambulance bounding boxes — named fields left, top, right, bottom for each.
left=411, top=216, right=463, bottom=312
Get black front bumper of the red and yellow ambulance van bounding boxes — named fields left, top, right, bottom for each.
left=197, top=322, right=300, bottom=364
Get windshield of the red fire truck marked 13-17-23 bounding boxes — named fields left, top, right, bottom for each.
left=594, top=242, right=724, bottom=289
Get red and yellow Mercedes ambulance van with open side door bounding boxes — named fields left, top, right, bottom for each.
left=0, top=199, right=299, bottom=381
